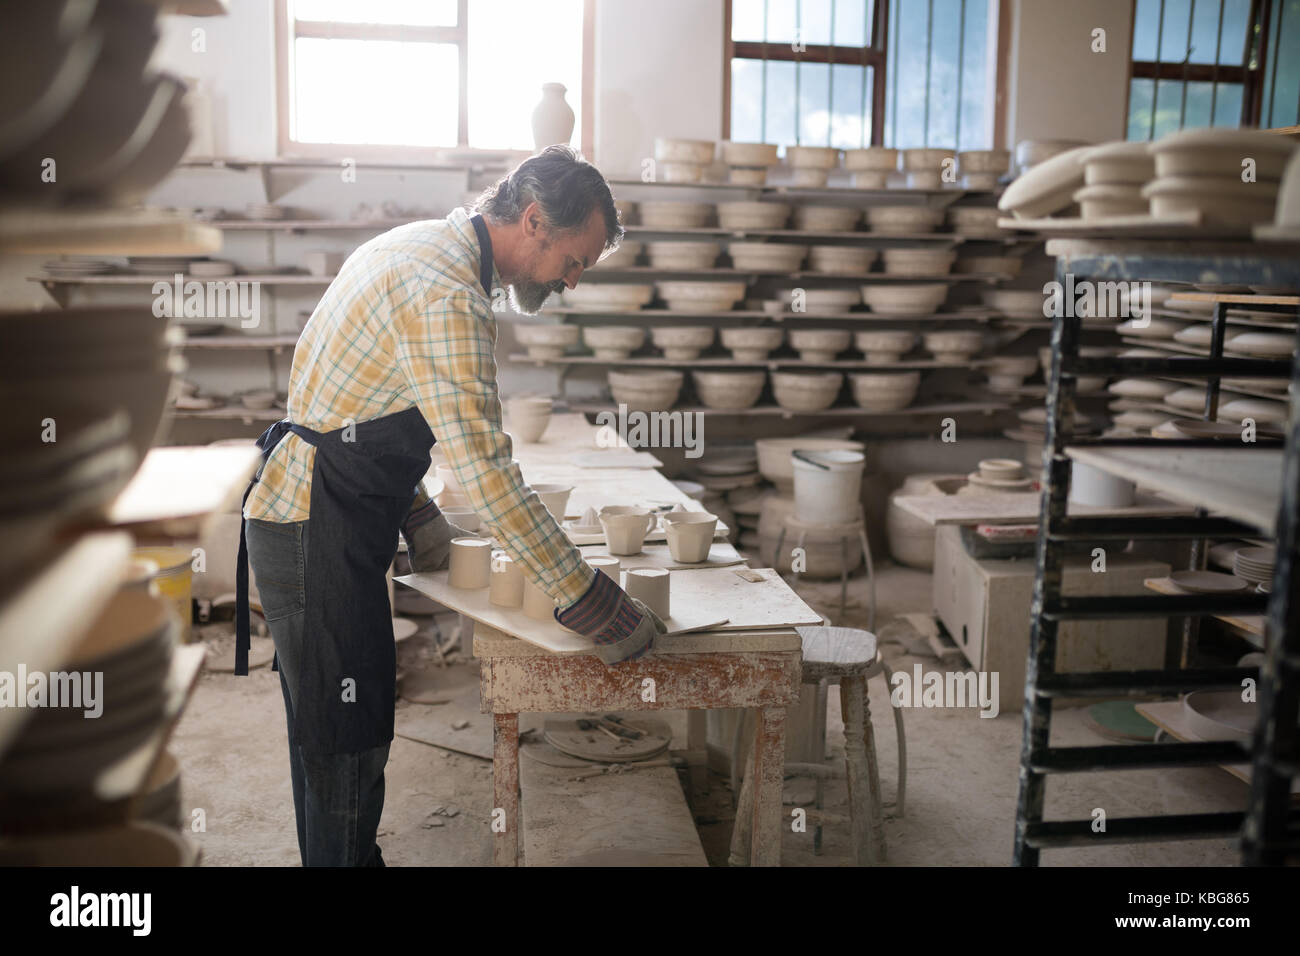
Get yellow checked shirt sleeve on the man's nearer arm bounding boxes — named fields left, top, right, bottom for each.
left=394, top=282, right=594, bottom=609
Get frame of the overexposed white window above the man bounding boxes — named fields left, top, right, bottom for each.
left=276, top=0, right=595, bottom=164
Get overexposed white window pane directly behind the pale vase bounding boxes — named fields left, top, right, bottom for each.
left=467, top=0, right=582, bottom=150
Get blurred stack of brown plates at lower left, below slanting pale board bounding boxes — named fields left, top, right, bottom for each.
left=0, top=589, right=179, bottom=801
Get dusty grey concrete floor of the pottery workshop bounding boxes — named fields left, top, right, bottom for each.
left=172, top=566, right=1247, bottom=866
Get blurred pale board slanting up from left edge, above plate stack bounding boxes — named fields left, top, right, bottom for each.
left=0, top=532, right=131, bottom=753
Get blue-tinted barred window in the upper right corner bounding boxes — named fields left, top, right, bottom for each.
left=1127, top=0, right=1300, bottom=139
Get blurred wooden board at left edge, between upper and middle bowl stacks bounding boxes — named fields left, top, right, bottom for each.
left=0, top=208, right=221, bottom=256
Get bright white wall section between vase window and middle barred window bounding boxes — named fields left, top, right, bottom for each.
left=594, top=0, right=724, bottom=176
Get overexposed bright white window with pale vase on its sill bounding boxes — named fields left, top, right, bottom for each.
left=278, top=0, right=590, bottom=156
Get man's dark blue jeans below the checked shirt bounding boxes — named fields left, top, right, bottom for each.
left=244, top=519, right=389, bottom=866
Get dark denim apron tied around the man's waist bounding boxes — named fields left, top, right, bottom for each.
left=235, top=216, right=493, bottom=753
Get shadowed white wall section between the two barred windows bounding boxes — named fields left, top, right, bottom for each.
left=1006, top=0, right=1132, bottom=146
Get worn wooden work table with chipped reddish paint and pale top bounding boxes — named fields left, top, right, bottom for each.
left=399, top=415, right=809, bottom=866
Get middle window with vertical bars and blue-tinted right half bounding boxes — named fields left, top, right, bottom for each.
left=725, top=0, right=997, bottom=150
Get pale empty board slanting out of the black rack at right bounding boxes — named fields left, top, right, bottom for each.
left=1065, top=447, right=1282, bottom=536
